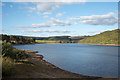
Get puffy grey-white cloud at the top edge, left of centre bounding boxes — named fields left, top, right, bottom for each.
left=27, top=2, right=60, bottom=15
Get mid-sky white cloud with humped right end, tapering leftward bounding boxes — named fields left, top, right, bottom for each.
left=17, top=18, right=71, bottom=28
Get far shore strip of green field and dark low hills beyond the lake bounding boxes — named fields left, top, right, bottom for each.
left=35, top=36, right=89, bottom=43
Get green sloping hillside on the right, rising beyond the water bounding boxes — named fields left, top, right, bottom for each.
left=79, top=29, right=120, bottom=44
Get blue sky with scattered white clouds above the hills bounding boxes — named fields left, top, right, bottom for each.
left=0, top=2, right=118, bottom=37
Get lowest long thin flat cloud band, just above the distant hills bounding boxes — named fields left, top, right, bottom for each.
left=22, top=29, right=71, bottom=33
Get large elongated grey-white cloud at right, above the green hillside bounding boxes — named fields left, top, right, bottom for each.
left=70, top=12, right=118, bottom=25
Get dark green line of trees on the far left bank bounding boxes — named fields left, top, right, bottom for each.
left=1, top=34, right=35, bottom=44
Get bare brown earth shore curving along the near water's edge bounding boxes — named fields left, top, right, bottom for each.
left=11, top=49, right=117, bottom=80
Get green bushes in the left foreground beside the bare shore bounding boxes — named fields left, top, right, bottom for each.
left=2, top=42, right=28, bottom=77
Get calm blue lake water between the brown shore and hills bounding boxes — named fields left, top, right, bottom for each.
left=14, top=44, right=118, bottom=77
